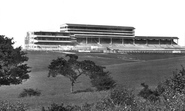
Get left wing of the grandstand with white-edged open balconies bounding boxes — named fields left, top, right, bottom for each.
left=25, top=31, right=76, bottom=50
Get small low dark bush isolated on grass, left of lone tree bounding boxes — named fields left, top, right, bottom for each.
left=19, top=88, right=41, bottom=97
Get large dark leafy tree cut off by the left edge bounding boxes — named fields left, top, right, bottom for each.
left=0, top=35, right=30, bottom=85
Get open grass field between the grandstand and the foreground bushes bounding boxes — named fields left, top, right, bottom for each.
left=0, top=52, right=185, bottom=109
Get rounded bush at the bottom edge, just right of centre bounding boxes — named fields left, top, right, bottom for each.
left=86, top=86, right=137, bottom=111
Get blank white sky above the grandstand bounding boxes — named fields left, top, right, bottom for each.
left=0, top=0, right=185, bottom=47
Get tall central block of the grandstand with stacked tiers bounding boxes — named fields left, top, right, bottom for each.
left=60, top=24, right=135, bottom=44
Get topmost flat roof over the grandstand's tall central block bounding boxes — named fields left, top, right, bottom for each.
left=61, top=23, right=135, bottom=29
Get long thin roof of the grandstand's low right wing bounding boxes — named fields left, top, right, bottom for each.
left=135, top=36, right=179, bottom=39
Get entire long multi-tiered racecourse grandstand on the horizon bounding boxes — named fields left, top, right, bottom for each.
left=25, top=24, right=185, bottom=53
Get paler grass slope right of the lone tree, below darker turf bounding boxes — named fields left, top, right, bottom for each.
left=107, top=56, right=185, bottom=89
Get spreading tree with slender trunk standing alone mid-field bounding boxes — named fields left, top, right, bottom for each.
left=48, top=54, right=115, bottom=92
